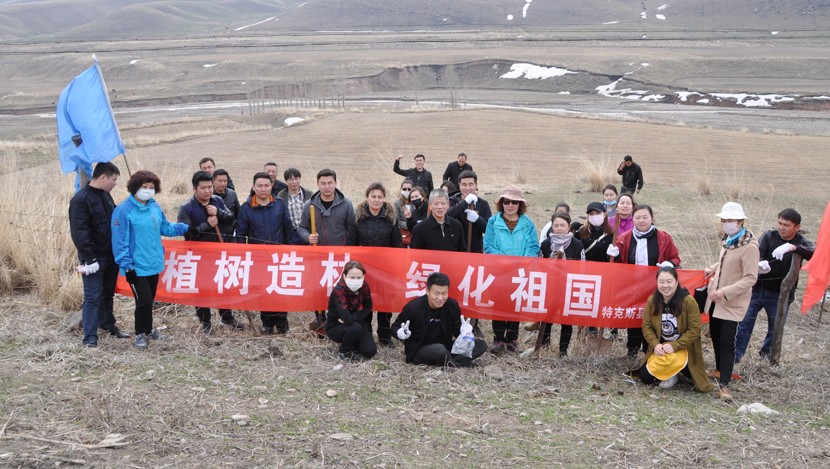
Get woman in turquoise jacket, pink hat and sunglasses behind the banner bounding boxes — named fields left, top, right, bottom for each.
left=484, top=186, right=539, bottom=353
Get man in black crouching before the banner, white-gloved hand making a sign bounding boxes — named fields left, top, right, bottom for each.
left=392, top=272, right=487, bottom=367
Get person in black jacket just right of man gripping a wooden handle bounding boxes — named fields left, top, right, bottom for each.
left=350, top=182, right=403, bottom=347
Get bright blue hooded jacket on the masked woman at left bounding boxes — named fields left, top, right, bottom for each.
left=112, top=194, right=189, bottom=277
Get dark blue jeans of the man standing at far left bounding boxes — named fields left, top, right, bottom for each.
left=81, top=258, right=118, bottom=344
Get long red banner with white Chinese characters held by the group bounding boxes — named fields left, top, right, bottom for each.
left=118, top=240, right=704, bottom=328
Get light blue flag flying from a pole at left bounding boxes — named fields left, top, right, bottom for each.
left=57, top=61, right=124, bottom=191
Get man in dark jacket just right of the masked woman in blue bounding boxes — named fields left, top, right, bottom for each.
left=178, top=171, right=244, bottom=334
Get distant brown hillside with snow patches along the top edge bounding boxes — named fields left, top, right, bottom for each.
left=0, top=0, right=830, bottom=41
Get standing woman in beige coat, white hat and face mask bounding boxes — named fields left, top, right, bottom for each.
left=703, top=202, right=760, bottom=401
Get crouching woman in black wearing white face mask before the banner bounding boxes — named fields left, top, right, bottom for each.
left=326, top=261, right=378, bottom=360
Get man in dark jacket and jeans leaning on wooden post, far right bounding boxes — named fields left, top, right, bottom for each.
left=735, top=208, right=815, bottom=363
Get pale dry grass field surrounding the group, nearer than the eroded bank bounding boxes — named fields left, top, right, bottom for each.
left=0, top=101, right=830, bottom=467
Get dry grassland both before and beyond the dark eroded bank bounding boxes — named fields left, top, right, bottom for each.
left=0, top=21, right=830, bottom=468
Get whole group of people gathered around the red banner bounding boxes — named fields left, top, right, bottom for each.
left=69, top=153, right=813, bottom=399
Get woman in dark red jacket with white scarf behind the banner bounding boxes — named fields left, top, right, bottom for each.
left=608, top=205, right=680, bottom=358
